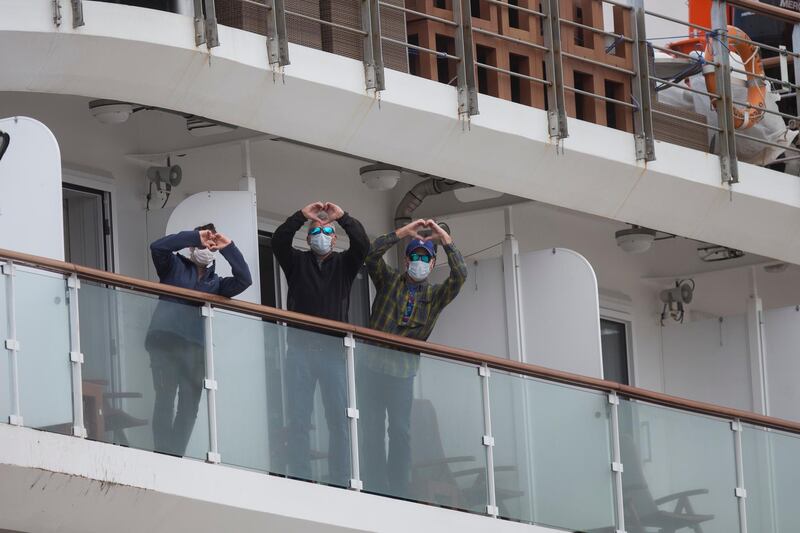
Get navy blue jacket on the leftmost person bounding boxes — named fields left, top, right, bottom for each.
left=147, top=230, right=253, bottom=344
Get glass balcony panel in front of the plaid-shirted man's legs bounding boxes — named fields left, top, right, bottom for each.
left=355, top=342, right=488, bottom=513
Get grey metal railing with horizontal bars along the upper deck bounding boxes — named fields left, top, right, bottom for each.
left=53, top=0, right=800, bottom=184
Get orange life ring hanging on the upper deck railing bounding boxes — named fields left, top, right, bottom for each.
left=703, top=26, right=766, bottom=130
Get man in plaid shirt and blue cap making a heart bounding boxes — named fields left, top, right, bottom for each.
left=358, top=219, right=467, bottom=498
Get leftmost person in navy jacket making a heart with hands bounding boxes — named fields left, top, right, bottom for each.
left=145, top=224, right=252, bottom=455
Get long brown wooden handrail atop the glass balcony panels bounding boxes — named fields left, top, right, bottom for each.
left=0, top=248, right=800, bottom=433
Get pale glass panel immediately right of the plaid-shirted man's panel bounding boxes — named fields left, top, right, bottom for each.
left=489, top=370, right=615, bottom=531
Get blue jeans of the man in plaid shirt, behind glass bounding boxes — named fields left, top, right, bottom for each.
left=358, top=367, right=414, bottom=498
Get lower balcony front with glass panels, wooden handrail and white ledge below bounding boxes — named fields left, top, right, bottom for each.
left=0, top=251, right=800, bottom=533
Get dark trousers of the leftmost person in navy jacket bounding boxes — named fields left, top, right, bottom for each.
left=147, top=332, right=205, bottom=455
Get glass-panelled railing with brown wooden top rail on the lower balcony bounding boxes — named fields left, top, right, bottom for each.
left=0, top=245, right=800, bottom=533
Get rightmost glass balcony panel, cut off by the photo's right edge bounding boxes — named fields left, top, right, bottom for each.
left=742, top=426, right=800, bottom=533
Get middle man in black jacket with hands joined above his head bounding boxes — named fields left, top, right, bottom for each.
left=272, top=202, right=369, bottom=486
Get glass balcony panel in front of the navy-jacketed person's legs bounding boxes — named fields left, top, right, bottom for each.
left=79, top=282, right=208, bottom=459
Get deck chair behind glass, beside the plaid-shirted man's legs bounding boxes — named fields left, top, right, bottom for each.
left=410, top=398, right=523, bottom=512
